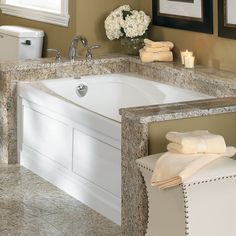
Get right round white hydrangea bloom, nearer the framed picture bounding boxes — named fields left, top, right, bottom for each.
left=122, top=10, right=151, bottom=38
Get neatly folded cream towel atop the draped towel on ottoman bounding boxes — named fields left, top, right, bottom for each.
left=166, top=130, right=226, bottom=154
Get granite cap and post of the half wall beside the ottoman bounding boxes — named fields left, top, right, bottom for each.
left=120, top=97, right=236, bottom=236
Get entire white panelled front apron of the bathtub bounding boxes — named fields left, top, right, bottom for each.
left=18, top=97, right=121, bottom=224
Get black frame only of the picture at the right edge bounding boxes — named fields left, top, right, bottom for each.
left=218, top=0, right=236, bottom=39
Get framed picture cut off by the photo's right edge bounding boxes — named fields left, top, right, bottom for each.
left=218, top=0, right=236, bottom=39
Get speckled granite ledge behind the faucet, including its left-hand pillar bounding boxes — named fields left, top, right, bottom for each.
left=0, top=55, right=129, bottom=163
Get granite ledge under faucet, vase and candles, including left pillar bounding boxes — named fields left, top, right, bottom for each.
left=0, top=55, right=236, bottom=163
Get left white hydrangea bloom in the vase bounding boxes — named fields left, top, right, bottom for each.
left=105, top=5, right=130, bottom=40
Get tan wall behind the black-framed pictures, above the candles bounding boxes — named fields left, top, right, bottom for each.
left=140, top=0, right=236, bottom=72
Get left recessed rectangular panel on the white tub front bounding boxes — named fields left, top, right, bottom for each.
left=23, top=107, right=73, bottom=170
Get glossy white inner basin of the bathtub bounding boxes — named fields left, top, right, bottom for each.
left=39, top=74, right=209, bottom=122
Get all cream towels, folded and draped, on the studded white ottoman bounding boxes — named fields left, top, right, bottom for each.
left=151, top=130, right=236, bottom=189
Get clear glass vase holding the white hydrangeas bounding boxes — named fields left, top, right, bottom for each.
left=120, top=36, right=145, bottom=56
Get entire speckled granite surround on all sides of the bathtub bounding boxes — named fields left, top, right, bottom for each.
left=0, top=55, right=236, bottom=236
